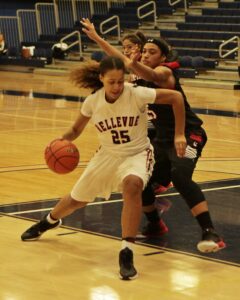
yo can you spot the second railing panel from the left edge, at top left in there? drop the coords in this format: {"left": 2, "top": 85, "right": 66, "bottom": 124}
{"left": 17, "top": 9, "right": 38, "bottom": 43}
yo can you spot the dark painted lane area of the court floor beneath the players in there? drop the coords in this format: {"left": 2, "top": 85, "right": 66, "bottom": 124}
{"left": 0, "top": 179, "right": 240, "bottom": 264}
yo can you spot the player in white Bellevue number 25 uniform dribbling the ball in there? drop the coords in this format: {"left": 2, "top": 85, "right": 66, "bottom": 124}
{"left": 21, "top": 57, "right": 186, "bottom": 280}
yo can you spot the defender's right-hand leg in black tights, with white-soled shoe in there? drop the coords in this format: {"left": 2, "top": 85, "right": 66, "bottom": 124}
{"left": 169, "top": 130, "right": 225, "bottom": 252}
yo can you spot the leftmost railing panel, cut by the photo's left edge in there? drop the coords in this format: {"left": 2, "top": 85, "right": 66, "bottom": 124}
{"left": 0, "top": 16, "right": 20, "bottom": 48}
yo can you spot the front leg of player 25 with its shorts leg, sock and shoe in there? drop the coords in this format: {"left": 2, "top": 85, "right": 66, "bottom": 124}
{"left": 118, "top": 149, "right": 154, "bottom": 280}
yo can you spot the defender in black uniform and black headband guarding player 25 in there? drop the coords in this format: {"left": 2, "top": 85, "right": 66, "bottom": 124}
{"left": 130, "top": 39, "right": 225, "bottom": 252}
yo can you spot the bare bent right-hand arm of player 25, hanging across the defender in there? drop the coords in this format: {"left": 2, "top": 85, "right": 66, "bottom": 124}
{"left": 155, "top": 89, "right": 187, "bottom": 157}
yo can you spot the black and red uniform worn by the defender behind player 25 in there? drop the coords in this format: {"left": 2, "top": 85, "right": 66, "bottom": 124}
{"left": 136, "top": 62, "right": 207, "bottom": 208}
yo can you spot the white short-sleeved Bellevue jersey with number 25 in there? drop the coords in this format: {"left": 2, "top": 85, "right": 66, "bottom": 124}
{"left": 81, "top": 83, "right": 156, "bottom": 156}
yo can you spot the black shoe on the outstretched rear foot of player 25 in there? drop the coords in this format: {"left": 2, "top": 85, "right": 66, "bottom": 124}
{"left": 21, "top": 217, "right": 62, "bottom": 241}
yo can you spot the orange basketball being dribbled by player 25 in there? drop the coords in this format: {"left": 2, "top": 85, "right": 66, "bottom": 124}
{"left": 45, "top": 140, "right": 80, "bottom": 174}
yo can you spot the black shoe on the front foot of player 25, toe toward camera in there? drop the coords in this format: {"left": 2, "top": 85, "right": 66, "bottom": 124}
{"left": 119, "top": 247, "right": 138, "bottom": 280}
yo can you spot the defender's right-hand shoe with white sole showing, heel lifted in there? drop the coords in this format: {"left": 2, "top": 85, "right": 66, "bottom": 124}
{"left": 197, "top": 228, "right": 226, "bottom": 253}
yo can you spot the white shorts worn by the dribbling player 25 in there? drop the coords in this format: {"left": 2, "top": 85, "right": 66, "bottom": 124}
{"left": 71, "top": 145, "right": 154, "bottom": 202}
